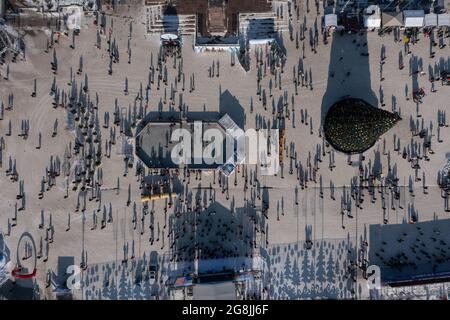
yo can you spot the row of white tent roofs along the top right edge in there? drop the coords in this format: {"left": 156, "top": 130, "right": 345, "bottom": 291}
{"left": 325, "top": 5, "right": 450, "bottom": 29}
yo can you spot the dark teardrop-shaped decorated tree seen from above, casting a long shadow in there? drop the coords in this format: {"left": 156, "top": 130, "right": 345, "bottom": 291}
{"left": 323, "top": 98, "right": 401, "bottom": 154}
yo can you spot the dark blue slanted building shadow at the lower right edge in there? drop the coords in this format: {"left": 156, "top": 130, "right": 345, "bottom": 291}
{"left": 369, "top": 219, "right": 450, "bottom": 286}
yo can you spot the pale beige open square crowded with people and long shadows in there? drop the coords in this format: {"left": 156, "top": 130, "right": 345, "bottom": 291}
{"left": 0, "top": 1, "right": 450, "bottom": 299}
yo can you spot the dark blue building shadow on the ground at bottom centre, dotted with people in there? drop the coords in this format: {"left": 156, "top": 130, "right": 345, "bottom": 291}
{"left": 169, "top": 202, "right": 257, "bottom": 278}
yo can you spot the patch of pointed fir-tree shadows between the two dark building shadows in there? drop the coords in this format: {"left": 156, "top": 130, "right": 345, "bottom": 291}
{"left": 263, "top": 239, "right": 356, "bottom": 300}
